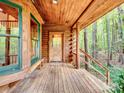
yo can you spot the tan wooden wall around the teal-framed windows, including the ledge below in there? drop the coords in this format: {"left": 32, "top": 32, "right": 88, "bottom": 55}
{"left": 0, "top": 0, "right": 43, "bottom": 88}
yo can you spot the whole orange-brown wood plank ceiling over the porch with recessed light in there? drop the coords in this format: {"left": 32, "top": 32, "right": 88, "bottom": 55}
{"left": 33, "top": 0, "right": 124, "bottom": 28}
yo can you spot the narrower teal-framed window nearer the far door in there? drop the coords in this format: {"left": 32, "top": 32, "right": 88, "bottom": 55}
{"left": 31, "top": 15, "right": 40, "bottom": 64}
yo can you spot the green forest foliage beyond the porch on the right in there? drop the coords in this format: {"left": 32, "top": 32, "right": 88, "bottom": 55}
{"left": 80, "top": 4, "right": 124, "bottom": 93}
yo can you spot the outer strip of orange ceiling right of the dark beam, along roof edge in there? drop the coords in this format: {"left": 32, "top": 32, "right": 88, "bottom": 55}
{"left": 80, "top": 0, "right": 124, "bottom": 29}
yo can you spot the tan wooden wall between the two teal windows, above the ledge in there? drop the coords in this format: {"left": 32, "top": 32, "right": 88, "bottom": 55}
{"left": 11, "top": 0, "right": 43, "bottom": 69}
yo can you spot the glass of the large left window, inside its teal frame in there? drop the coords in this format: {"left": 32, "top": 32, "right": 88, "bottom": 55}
{"left": 0, "top": 2, "right": 19, "bottom": 66}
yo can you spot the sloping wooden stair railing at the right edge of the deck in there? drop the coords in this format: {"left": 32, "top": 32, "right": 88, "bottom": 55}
{"left": 80, "top": 49, "right": 110, "bottom": 84}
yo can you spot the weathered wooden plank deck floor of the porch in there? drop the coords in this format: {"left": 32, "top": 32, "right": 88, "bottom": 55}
{"left": 11, "top": 63, "right": 108, "bottom": 93}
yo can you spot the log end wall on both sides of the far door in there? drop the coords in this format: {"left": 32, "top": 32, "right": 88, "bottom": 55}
{"left": 42, "top": 29, "right": 76, "bottom": 65}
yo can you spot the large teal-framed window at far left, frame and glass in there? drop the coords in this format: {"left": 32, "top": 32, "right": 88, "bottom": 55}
{"left": 0, "top": 1, "right": 21, "bottom": 72}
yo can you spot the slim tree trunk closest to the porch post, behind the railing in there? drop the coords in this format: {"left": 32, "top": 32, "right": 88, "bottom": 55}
{"left": 84, "top": 28, "right": 88, "bottom": 70}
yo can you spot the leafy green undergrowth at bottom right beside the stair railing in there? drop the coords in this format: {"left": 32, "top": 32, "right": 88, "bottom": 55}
{"left": 92, "top": 64, "right": 124, "bottom": 93}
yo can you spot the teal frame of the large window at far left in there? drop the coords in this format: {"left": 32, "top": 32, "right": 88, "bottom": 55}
{"left": 0, "top": 0, "right": 22, "bottom": 75}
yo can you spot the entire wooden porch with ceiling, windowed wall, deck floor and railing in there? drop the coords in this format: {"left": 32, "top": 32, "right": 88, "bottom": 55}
{"left": 0, "top": 0, "right": 124, "bottom": 93}
